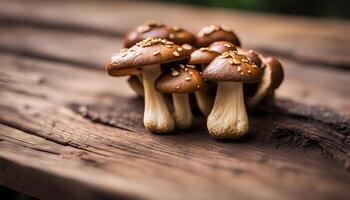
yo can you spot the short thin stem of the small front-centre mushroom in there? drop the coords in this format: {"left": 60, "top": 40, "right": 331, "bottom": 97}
{"left": 172, "top": 93, "right": 193, "bottom": 129}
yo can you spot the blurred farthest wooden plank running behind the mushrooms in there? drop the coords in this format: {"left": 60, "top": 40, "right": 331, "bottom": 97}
{"left": 0, "top": 1, "right": 350, "bottom": 69}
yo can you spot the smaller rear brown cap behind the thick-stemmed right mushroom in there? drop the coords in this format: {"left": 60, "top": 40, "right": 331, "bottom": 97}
{"left": 197, "top": 25, "right": 241, "bottom": 47}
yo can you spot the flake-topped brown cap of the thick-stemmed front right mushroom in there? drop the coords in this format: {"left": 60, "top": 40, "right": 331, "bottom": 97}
{"left": 203, "top": 51, "right": 263, "bottom": 83}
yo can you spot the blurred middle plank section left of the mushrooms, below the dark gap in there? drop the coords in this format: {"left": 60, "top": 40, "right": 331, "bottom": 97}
{"left": 0, "top": 25, "right": 122, "bottom": 69}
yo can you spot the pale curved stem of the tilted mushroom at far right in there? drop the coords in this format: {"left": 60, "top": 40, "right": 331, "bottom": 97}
{"left": 247, "top": 67, "right": 273, "bottom": 108}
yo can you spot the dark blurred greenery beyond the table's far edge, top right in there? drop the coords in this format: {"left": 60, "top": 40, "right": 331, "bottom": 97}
{"left": 163, "top": 0, "right": 350, "bottom": 18}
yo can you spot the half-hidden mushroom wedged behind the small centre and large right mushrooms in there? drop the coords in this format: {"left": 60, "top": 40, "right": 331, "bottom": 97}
{"left": 188, "top": 48, "right": 220, "bottom": 116}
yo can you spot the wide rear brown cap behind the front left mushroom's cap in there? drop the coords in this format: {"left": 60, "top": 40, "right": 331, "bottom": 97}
{"left": 124, "top": 22, "right": 196, "bottom": 48}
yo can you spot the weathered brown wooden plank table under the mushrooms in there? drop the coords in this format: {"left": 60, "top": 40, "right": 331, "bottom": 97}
{"left": 0, "top": 1, "right": 350, "bottom": 200}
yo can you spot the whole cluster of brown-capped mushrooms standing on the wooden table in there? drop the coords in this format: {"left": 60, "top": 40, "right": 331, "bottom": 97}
{"left": 106, "top": 22, "right": 284, "bottom": 139}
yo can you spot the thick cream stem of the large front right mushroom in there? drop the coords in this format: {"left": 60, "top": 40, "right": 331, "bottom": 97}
{"left": 207, "top": 82, "right": 249, "bottom": 138}
